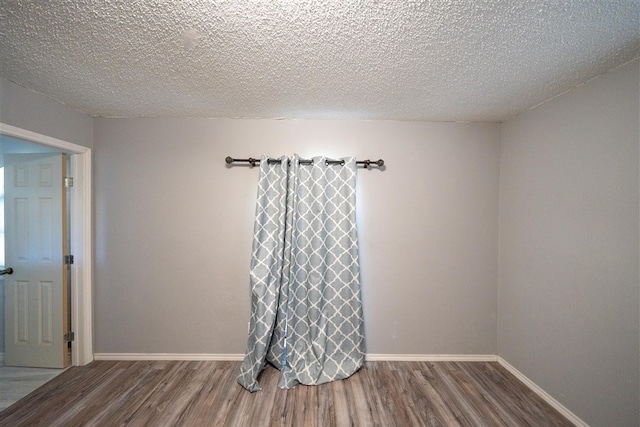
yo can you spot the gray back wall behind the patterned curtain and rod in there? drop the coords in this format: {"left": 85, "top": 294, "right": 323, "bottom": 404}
{"left": 94, "top": 119, "right": 499, "bottom": 355}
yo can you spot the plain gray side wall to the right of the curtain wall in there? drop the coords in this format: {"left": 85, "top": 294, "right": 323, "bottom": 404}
{"left": 498, "top": 60, "right": 640, "bottom": 426}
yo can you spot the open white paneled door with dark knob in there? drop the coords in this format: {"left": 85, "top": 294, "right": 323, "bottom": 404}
{"left": 3, "top": 153, "right": 68, "bottom": 368}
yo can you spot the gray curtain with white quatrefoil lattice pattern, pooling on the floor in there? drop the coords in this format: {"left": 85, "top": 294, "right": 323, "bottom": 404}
{"left": 238, "top": 155, "right": 364, "bottom": 392}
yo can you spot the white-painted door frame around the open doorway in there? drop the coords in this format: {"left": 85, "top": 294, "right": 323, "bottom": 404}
{"left": 0, "top": 122, "right": 94, "bottom": 366}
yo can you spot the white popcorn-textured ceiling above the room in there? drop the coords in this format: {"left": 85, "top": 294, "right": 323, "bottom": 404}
{"left": 0, "top": 0, "right": 640, "bottom": 121}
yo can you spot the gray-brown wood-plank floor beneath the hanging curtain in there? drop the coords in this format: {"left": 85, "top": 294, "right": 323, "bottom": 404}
{"left": 0, "top": 361, "right": 572, "bottom": 427}
